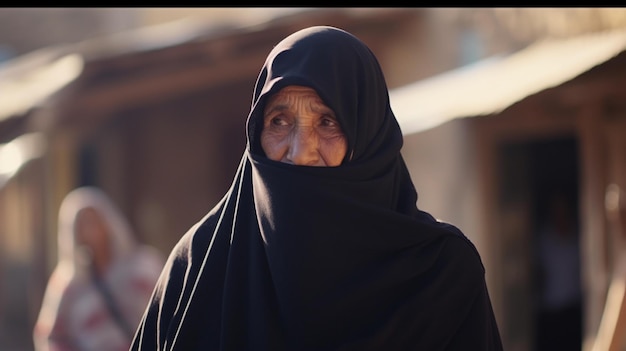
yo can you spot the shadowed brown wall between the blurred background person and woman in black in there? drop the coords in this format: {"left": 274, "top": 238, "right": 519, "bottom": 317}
{"left": 120, "top": 81, "right": 251, "bottom": 253}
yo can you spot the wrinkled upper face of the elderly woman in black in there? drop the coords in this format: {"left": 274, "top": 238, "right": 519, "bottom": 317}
{"left": 261, "top": 85, "right": 348, "bottom": 167}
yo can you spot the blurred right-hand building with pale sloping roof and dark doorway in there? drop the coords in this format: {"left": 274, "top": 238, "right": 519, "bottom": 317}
{"left": 392, "top": 24, "right": 626, "bottom": 350}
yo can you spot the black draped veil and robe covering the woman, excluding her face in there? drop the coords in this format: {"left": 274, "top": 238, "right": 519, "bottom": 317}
{"left": 131, "top": 27, "right": 502, "bottom": 351}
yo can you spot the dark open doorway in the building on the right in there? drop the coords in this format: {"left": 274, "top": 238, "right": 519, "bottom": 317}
{"left": 497, "top": 136, "right": 583, "bottom": 351}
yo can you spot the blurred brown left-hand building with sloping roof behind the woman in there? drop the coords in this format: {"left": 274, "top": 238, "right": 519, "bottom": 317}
{"left": 0, "top": 9, "right": 434, "bottom": 350}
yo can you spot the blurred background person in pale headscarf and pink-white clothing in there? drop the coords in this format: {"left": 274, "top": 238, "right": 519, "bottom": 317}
{"left": 33, "top": 187, "right": 165, "bottom": 351}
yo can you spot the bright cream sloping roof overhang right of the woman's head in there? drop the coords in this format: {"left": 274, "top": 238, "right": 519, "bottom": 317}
{"left": 390, "top": 30, "right": 626, "bottom": 135}
